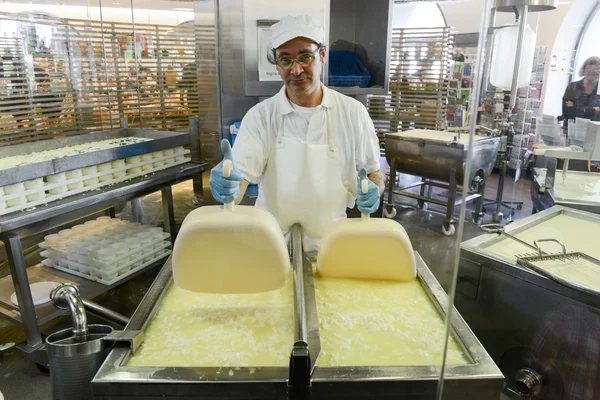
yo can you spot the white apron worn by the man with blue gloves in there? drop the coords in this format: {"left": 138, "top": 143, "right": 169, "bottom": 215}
{"left": 256, "top": 110, "right": 353, "bottom": 251}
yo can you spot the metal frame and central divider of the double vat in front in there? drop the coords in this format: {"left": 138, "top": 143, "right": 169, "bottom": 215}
{"left": 93, "top": 244, "right": 503, "bottom": 400}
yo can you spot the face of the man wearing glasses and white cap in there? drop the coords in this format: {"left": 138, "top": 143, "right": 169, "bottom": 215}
{"left": 275, "top": 38, "right": 326, "bottom": 96}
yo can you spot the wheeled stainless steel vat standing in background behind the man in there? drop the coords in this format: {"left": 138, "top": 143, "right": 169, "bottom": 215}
{"left": 385, "top": 130, "right": 500, "bottom": 236}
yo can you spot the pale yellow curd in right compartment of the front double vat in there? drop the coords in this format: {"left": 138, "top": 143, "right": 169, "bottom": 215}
{"left": 315, "top": 270, "right": 471, "bottom": 367}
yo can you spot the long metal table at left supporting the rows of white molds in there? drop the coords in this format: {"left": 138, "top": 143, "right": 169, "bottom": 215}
{"left": 0, "top": 163, "right": 207, "bottom": 363}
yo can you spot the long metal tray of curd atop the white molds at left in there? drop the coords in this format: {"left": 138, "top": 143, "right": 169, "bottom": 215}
{"left": 0, "top": 128, "right": 190, "bottom": 187}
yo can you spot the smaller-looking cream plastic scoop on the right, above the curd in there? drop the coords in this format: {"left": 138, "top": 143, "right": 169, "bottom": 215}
{"left": 317, "top": 218, "right": 417, "bottom": 281}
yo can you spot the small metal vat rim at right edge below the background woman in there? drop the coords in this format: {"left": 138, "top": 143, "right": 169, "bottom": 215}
{"left": 531, "top": 168, "right": 600, "bottom": 214}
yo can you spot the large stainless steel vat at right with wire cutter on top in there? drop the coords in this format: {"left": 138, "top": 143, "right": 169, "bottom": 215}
{"left": 455, "top": 206, "right": 600, "bottom": 398}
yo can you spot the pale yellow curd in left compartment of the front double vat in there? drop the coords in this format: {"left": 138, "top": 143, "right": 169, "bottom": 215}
{"left": 127, "top": 279, "right": 294, "bottom": 368}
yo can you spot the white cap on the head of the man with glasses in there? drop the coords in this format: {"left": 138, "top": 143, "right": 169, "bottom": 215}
{"left": 270, "top": 15, "right": 325, "bottom": 50}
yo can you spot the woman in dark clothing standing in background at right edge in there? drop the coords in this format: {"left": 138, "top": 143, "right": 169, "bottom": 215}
{"left": 563, "top": 56, "right": 600, "bottom": 129}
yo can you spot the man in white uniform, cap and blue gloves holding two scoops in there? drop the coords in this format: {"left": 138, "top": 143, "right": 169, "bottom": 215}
{"left": 210, "top": 16, "right": 385, "bottom": 248}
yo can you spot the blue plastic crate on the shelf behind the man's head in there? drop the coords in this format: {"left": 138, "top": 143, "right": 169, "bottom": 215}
{"left": 329, "top": 50, "right": 371, "bottom": 87}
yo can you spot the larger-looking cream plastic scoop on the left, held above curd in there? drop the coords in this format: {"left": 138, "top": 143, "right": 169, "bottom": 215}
{"left": 172, "top": 206, "right": 290, "bottom": 293}
